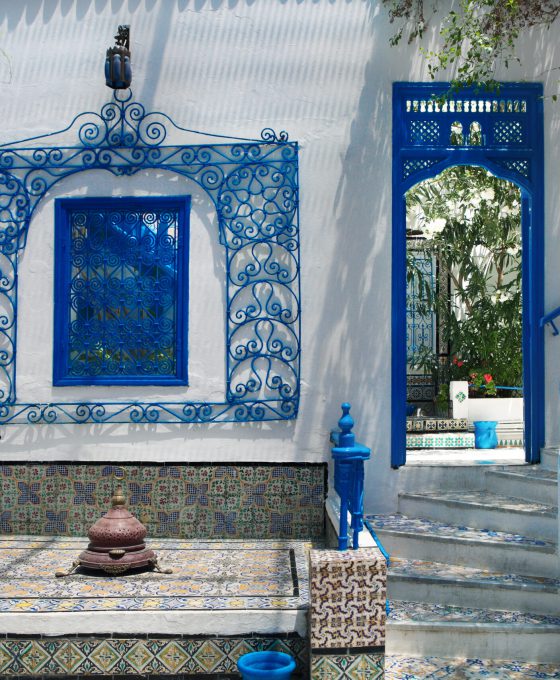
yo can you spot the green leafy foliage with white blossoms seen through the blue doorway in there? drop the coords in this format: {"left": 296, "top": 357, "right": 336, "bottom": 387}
{"left": 406, "top": 166, "right": 522, "bottom": 396}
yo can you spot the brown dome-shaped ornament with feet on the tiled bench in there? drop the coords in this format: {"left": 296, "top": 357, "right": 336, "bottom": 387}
{"left": 55, "top": 486, "right": 172, "bottom": 576}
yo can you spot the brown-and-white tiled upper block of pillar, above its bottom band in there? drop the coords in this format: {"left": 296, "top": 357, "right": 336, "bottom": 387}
{"left": 309, "top": 548, "right": 387, "bottom": 649}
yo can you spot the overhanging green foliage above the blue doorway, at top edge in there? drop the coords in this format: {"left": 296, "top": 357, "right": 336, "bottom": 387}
{"left": 382, "top": 0, "right": 560, "bottom": 94}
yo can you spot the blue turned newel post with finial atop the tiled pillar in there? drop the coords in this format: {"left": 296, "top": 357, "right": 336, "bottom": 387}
{"left": 331, "top": 402, "right": 371, "bottom": 550}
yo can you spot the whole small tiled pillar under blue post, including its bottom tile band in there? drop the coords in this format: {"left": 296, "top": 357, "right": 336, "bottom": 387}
{"left": 309, "top": 548, "right": 387, "bottom": 680}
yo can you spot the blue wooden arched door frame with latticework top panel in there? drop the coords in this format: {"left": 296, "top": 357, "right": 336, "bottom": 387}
{"left": 391, "top": 83, "right": 544, "bottom": 468}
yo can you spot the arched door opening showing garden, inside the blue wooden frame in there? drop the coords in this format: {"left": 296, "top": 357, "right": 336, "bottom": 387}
{"left": 406, "top": 165, "right": 525, "bottom": 464}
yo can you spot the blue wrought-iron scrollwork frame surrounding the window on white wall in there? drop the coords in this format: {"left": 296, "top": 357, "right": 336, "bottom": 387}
{"left": 0, "top": 90, "right": 300, "bottom": 423}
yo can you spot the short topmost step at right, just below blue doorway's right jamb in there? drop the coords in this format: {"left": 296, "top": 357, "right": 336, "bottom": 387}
{"left": 486, "top": 465, "right": 558, "bottom": 505}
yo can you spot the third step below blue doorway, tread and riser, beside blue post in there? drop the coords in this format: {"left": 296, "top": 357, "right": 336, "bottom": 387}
{"left": 367, "top": 514, "right": 558, "bottom": 578}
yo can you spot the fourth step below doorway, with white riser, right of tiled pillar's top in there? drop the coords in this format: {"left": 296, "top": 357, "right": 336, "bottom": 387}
{"left": 388, "top": 557, "right": 560, "bottom": 615}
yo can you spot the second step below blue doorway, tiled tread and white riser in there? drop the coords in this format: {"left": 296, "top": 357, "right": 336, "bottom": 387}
{"left": 399, "top": 491, "right": 558, "bottom": 542}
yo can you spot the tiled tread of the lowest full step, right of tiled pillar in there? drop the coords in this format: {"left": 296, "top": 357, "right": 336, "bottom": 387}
{"left": 389, "top": 600, "right": 560, "bottom": 634}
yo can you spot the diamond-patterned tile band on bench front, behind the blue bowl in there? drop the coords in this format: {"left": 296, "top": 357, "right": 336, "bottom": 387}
{"left": 0, "top": 636, "right": 308, "bottom": 679}
